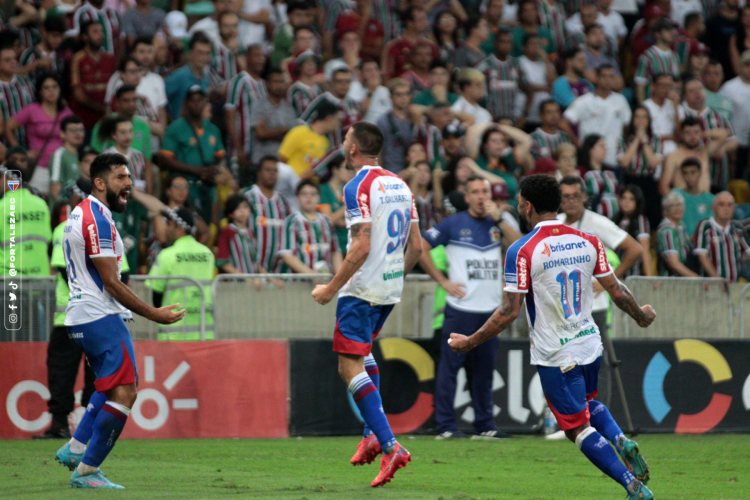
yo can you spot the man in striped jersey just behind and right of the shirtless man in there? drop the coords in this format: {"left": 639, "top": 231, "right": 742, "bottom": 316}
{"left": 678, "top": 78, "right": 737, "bottom": 190}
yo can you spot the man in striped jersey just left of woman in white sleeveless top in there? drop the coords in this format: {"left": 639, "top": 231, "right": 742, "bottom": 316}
{"left": 476, "top": 27, "right": 527, "bottom": 122}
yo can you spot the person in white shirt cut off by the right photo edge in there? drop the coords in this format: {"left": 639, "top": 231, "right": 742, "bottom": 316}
{"left": 720, "top": 49, "right": 750, "bottom": 178}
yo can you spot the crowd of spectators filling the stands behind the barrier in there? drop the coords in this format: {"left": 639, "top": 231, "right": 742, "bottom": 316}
{"left": 0, "top": 0, "right": 750, "bottom": 292}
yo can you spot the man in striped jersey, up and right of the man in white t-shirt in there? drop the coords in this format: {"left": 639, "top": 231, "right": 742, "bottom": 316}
{"left": 634, "top": 19, "right": 680, "bottom": 103}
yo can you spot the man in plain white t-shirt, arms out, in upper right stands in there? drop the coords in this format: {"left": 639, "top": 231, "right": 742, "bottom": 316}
{"left": 560, "top": 64, "right": 632, "bottom": 165}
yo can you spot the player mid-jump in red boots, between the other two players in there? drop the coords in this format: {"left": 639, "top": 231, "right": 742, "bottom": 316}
{"left": 312, "top": 122, "right": 422, "bottom": 487}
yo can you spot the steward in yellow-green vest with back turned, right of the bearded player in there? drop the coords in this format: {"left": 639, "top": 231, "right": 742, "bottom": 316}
{"left": 146, "top": 207, "right": 216, "bottom": 340}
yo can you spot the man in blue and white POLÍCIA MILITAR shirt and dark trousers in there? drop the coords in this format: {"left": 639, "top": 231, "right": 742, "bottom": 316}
{"left": 419, "top": 176, "right": 520, "bottom": 439}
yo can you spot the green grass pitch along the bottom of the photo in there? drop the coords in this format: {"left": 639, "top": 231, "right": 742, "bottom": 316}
{"left": 0, "top": 434, "right": 750, "bottom": 500}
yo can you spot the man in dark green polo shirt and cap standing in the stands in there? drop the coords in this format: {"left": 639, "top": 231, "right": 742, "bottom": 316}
{"left": 159, "top": 85, "right": 226, "bottom": 225}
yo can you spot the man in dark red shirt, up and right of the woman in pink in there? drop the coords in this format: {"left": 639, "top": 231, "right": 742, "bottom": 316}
{"left": 70, "top": 21, "right": 117, "bottom": 135}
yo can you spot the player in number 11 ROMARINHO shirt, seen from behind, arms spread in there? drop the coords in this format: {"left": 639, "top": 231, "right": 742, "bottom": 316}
{"left": 448, "top": 175, "right": 656, "bottom": 500}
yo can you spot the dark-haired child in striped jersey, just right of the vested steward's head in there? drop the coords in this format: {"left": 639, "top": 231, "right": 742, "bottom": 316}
{"left": 216, "top": 194, "right": 260, "bottom": 274}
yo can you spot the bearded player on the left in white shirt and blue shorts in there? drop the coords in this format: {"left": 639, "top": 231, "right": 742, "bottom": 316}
{"left": 55, "top": 154, "right": 185, "bottom": 489}
